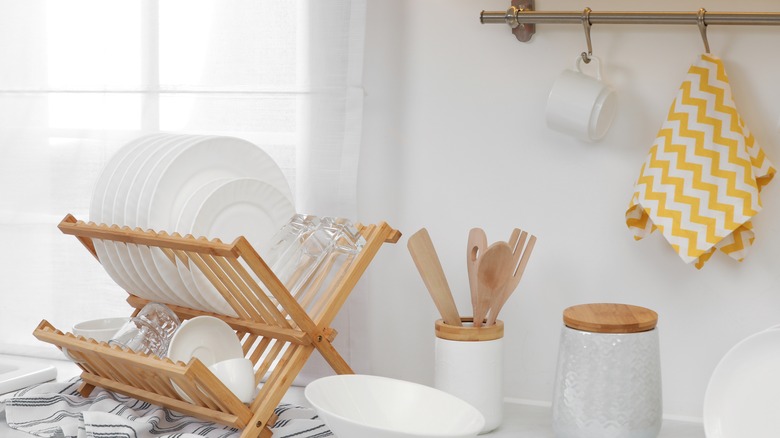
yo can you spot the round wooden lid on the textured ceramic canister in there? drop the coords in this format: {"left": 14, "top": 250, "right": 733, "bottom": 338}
{"left": 563, "top": 303, "right": 658, "bottom": 333}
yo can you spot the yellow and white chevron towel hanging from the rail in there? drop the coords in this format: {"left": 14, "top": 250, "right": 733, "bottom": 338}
{"left": 626, "top": 54, "right": 775, "bottom": 269}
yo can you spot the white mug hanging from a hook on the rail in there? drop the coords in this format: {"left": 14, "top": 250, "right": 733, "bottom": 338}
{"left": 547, "top": 56, "right": 617, "bottom": 142}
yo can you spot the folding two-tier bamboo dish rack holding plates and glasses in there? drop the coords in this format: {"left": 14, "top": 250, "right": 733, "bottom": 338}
{"left": 33, "top": 215, "right": 401, "bottom": 438}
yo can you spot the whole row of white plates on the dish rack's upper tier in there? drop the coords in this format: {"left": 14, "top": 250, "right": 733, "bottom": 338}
{"left": 89, "top": 134, "right": 295, "bottom": 316}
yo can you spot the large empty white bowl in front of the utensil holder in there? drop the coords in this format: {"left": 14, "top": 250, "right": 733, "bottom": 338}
{"left": 304, "top": 374, "right": 485, "bottom": 438}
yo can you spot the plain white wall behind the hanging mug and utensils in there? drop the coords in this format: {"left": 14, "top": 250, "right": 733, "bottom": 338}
{"left": 359, "top": 0, "right": 780, "bottom": 417}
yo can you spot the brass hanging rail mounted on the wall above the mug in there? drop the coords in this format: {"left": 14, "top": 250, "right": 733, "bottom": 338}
{"left": 479, "top": 0, "right": 780, "bottom": 41}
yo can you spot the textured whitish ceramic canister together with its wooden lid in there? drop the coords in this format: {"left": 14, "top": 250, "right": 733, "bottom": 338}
{"left": 553, "top": 304, "right": 662, "bottom": 438}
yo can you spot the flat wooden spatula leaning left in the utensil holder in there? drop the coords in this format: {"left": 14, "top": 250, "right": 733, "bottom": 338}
{"left": 406, "top": 228, "right": 463, "bottom": 326}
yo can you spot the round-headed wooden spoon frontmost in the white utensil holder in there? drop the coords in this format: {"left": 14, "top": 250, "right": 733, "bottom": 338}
{"left": 474, "top": 242, "right": 514, "bottom": 327}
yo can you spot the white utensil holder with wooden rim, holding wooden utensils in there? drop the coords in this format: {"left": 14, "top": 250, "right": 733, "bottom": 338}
{"left": 434, "top": 318, "right": 504, "bottom": 434}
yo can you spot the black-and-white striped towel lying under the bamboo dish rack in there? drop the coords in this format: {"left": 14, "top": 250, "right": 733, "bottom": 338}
{"left": 5, "top": 378, "right": 334, "bottom": 438}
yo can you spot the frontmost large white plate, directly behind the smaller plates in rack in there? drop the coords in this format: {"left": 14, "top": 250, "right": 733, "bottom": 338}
{"left": 137, "top": 137, "right": 292, "bottom": 316}
